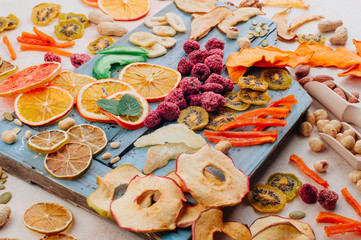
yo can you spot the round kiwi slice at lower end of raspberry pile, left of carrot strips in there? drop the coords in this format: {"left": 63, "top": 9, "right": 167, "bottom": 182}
{"left": 177, "top": 106, "right": 209, "bottom": 130}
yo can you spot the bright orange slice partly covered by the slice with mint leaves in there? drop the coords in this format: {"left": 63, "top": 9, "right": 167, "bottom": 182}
{"left": 76, "top": 78, "right": 135, "bottom": 123}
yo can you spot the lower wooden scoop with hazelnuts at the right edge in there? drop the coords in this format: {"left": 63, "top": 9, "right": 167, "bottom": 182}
{"left": 319, "top": 122, "right": 361, "bottom": 170}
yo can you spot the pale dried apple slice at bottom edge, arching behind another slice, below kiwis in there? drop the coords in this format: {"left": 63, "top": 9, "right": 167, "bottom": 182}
{"left": 250, "top": 215, "right": 315, "bottom": 240}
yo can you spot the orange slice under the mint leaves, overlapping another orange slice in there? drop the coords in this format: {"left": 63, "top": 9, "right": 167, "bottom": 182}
{"left": 104, "top": 91, "right": 149, "bottom": 130}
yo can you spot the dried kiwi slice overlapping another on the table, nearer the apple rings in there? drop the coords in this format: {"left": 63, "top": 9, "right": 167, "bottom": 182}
{"left": 247, "top": 183, "right": 287, "bottom": 213}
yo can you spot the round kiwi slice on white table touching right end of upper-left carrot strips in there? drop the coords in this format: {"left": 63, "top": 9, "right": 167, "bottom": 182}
{"left": 54, "top": 19, "right": 84, "bottom": 41}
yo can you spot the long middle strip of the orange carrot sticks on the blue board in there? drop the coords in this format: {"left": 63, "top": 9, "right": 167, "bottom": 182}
{"left": 218, "top": 118, "right": 287, "bottom": 131}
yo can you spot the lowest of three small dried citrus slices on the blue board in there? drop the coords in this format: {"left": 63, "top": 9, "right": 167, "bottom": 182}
{"left": 44, "top": 143, "right": 93, "bottom": 180}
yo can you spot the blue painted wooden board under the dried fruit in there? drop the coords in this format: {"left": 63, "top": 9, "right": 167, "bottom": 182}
{"left": 0, "top": 3, "right": 312, "bottom": 240}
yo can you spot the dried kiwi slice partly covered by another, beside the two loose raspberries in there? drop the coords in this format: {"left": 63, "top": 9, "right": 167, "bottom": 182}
{"left": 266, "top": 173, "right": 302, "bottom": 201}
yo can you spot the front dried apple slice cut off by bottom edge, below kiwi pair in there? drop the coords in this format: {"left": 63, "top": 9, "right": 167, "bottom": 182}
{"left": 252, "top": 222, "right": 309, "bottom": 240}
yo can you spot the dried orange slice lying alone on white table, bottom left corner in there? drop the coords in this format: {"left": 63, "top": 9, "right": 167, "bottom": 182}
{"left": 24, "top": 202, "right": 73, "bottom": 234}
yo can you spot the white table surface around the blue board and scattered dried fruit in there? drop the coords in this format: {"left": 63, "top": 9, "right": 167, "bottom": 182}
{"left": 0, "top": 0, "right": 361, "bottom": 240}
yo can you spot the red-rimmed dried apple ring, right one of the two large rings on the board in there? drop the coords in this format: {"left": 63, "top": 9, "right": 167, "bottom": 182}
{"left": 176, "top": 144, "right": 249, "bottom": 207}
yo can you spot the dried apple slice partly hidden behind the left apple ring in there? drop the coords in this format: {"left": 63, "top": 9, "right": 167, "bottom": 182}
{"left": 87, "top": 164, "right": 146, "bottom": 218}
